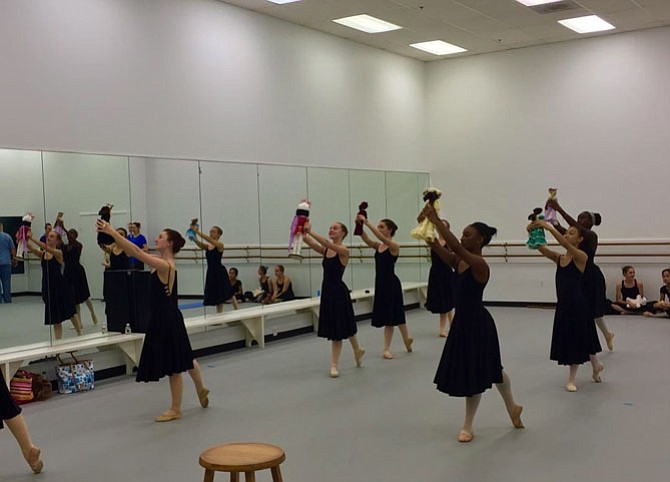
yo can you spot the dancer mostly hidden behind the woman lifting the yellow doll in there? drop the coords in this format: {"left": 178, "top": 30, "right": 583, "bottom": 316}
{"left": 426, "top": 219, "right": 454, "bottom": 338}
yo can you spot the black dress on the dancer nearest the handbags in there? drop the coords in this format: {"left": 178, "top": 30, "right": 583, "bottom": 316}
{"left": 135, "top": 267, "right": 193, "bottom": 382}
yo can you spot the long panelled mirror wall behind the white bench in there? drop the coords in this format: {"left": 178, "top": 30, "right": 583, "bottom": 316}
{"left": 0, "top": 145, "right": 429, "bottom": 350}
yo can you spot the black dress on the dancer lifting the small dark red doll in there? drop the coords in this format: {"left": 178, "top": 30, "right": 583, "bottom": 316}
{"left": 372, "top": 249, "right": 405, "bottom": 328}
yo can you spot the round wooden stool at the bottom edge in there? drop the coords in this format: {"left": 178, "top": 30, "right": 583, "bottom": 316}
{"left": 198, "top": 442, "right": 286, "bottom": 482}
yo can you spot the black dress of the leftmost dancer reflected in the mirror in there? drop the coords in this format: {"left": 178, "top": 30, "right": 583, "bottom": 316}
{"left": 41, "top": 253, "right": 77, "bottom": 325}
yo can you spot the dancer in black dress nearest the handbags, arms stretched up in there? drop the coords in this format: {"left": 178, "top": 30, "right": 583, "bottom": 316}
{"left": 96, "top": 219, "right": 209, "bottom": 422}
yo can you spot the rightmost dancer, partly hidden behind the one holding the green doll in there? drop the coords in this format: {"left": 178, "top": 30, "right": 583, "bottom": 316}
{"left": 547, "top": 199, "right": 614, "bottom": 351}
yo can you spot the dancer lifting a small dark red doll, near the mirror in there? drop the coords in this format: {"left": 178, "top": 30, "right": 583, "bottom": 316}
{"left": 356, "top": 214, "right": 414, "bottom": 360}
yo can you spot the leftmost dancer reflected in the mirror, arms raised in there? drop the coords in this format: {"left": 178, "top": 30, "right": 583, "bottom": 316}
{"left": 28, "top": 229, "right": 82, "bottom": 340}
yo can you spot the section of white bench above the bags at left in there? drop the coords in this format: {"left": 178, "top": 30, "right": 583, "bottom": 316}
{"left": 0, "top": 333, "right": 144, "bottom": 384}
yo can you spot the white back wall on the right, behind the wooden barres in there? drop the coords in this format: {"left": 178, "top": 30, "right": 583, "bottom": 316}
{"left": 426, "top": 28, "right": 670, "bottom": 301}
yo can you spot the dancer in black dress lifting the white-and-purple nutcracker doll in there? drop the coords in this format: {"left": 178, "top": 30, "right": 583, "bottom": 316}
{"left": 303, "top": 221, "right": 365, "bottom": 378}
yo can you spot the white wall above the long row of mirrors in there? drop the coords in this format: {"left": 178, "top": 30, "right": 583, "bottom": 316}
{"left": 0, "top": 0, "right": 424, "bottom": 170}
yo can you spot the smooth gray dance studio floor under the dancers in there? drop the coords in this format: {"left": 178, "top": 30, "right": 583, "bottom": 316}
{"left": 0, "top": 308, "right": 670, "bottom": 482}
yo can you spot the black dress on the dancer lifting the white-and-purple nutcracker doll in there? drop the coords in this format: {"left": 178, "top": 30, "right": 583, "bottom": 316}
{"left": 317, "top": 250, "right": 358, "bottom": 341}
